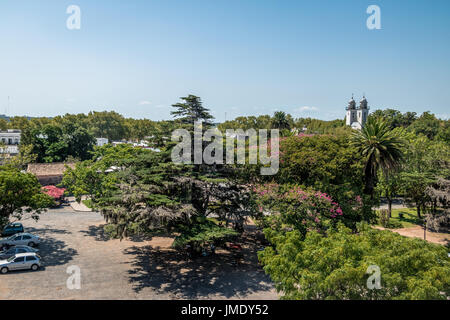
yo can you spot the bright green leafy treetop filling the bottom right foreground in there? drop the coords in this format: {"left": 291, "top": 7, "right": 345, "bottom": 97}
{"left": 259, "top": 222, "right": 450, "bottom": 300}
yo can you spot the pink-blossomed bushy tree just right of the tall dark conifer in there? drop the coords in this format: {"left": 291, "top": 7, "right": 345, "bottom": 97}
{"left": 253, "top": 183, "right": 343, "bottom": 238}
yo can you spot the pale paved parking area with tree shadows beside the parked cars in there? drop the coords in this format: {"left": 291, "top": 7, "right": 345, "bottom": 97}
{"left": 0, "top": 207, "right": 277, "bottom": 299}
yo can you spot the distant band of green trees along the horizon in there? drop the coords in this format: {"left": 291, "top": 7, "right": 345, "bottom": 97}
{"left": 0, "top": 109, "right": 450, "bottom": 142}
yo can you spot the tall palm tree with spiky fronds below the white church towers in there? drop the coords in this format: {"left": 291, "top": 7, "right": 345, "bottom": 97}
{"left": 351, "top": 117, "right": 405, "bottom": 197}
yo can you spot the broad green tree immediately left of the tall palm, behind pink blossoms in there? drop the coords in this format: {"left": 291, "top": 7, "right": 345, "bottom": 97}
{"left": 278, "top": 133, "right": 374, "bottom": 224}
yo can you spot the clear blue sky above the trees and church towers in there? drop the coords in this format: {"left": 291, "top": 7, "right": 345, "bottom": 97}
{"left": 0, "top": 0, "right": 450, "bottom": 121}
